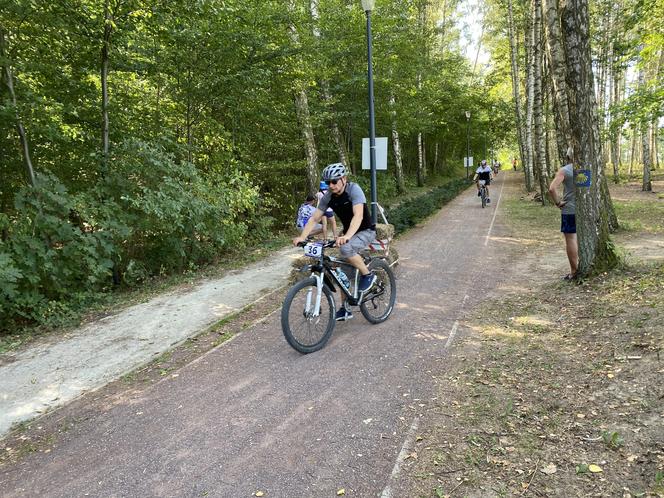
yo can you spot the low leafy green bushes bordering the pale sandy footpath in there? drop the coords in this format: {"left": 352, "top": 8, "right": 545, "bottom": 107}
{"left": 0, "top": 140, "right": 271, "bottom": 332}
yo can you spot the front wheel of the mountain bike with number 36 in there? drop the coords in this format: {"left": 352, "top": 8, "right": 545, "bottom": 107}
{"left": 281, "top": 277, "right": 336, "bottom": 354}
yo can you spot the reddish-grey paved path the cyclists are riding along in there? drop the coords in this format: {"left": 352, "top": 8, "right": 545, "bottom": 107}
{"left": 0, "top": 173, "right": 517, "bottom": 498}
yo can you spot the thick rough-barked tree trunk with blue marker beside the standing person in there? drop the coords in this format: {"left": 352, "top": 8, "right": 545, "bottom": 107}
{"left": 561, "top": 0, "right": 618, "bottom": 276}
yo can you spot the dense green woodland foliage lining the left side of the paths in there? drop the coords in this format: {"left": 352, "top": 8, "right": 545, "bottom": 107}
{"left": 0, "top": 0, "right": 492, "bottom": 330}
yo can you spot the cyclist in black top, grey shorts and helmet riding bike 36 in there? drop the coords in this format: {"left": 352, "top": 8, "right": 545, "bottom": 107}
{"left": 293, "top": 163, "right": 376, "bottom": 320}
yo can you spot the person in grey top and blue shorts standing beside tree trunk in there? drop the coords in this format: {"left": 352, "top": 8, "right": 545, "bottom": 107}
{"left": 549, "top": 147, "right": 579, "bottom": 280}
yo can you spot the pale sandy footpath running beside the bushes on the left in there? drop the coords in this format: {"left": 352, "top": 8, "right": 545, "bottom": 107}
{"left": 0, "top": 248, "right": 299, "bottom": 437}
